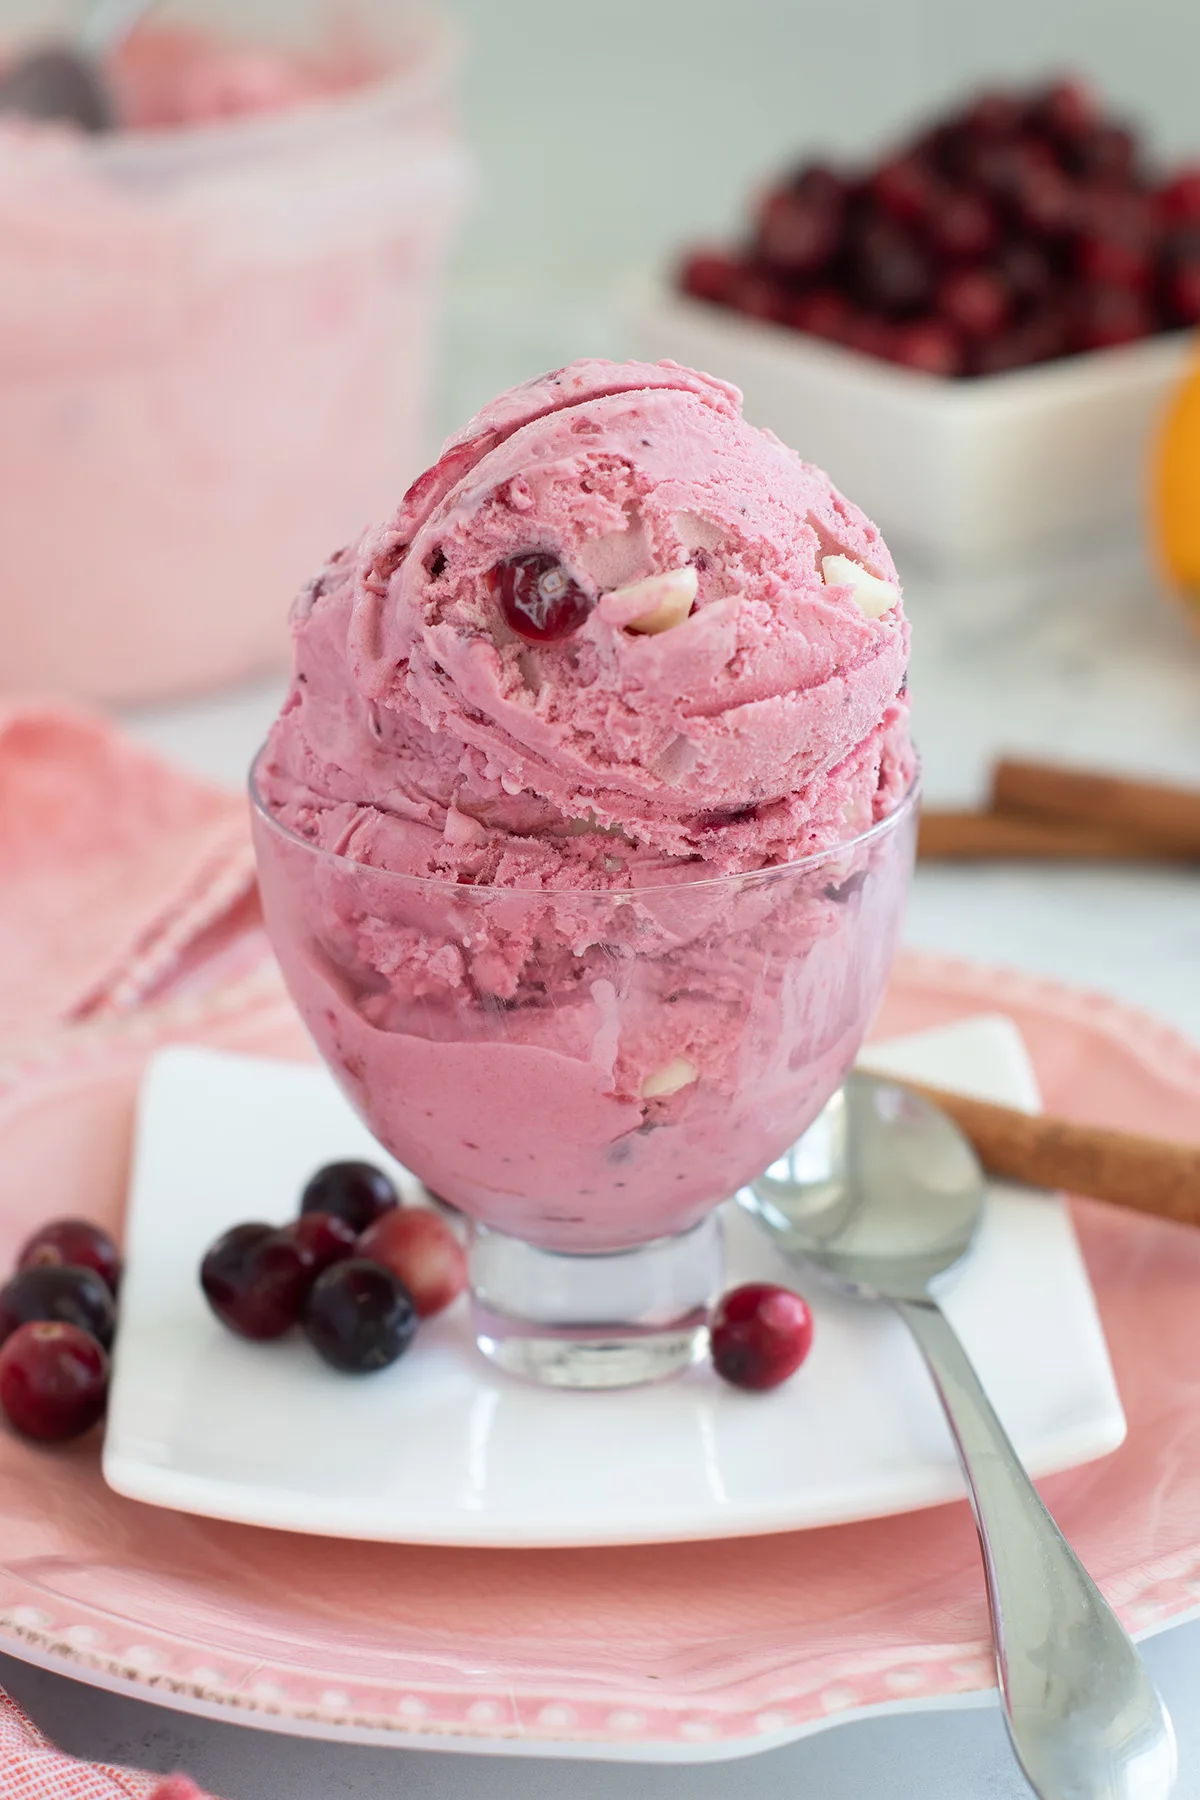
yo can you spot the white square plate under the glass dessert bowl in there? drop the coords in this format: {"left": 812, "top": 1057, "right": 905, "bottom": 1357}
{"left": 104, "top": 1017, "right": 1124, "bottom": 1546}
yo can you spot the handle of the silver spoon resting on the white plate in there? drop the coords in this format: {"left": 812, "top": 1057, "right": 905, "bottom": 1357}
{"left": 896, "top": 1300, "right": 1175, "bottom": 1800}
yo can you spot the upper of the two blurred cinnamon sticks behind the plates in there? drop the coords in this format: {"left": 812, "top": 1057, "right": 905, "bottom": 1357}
{"left": 991, "top": 758, "right": 1200, "bottom": 860}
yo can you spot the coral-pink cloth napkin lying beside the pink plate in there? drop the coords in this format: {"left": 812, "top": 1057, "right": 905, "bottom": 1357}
{"left": 0, "top": 706, "right": 244, "bottom": 1800}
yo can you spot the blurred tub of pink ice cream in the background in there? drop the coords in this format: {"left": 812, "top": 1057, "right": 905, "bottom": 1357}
{"left": 0, "top": 0, "right": 468, "bottom": 704}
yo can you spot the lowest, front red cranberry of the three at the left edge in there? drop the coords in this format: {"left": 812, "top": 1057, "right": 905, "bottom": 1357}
{"left": 0, "top": 1319, "right": 108, "bottom": 1444}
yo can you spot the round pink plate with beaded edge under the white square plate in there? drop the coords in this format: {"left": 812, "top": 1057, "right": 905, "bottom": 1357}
{"left": 0, "top": 956, "right": 1200, "bottom": 1760}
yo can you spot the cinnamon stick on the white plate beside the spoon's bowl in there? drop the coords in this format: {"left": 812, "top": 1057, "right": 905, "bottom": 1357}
{"left": 905, "top": 1082, "right": 1200, "bottom": 1226}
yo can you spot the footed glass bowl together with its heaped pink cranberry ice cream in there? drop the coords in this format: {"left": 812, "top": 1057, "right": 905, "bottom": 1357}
{"left": 254, "top": 362, "right": 916, "bottom": 1388}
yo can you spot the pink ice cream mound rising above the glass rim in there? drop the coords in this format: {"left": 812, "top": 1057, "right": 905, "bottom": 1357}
{"left": 263, "top": 362, "right": 912, "bottom": 887}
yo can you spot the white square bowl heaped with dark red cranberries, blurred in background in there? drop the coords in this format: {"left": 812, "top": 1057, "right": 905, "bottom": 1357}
{"left": 631, "top": 81, "right": 1200, "bottom": 563}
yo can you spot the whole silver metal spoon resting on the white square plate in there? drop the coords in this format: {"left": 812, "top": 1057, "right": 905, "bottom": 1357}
{"left": 738, "top": 1075, "right": 1177, "bottom": 1800}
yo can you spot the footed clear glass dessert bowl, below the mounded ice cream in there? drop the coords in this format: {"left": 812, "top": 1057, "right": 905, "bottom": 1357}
{"left": 252, "top": 774, "right": 918, "bottom": 1388}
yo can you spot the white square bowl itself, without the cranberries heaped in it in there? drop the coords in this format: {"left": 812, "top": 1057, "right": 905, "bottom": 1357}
{"left": 626, "top": 290, "right": 1193, "bottom": 567}
